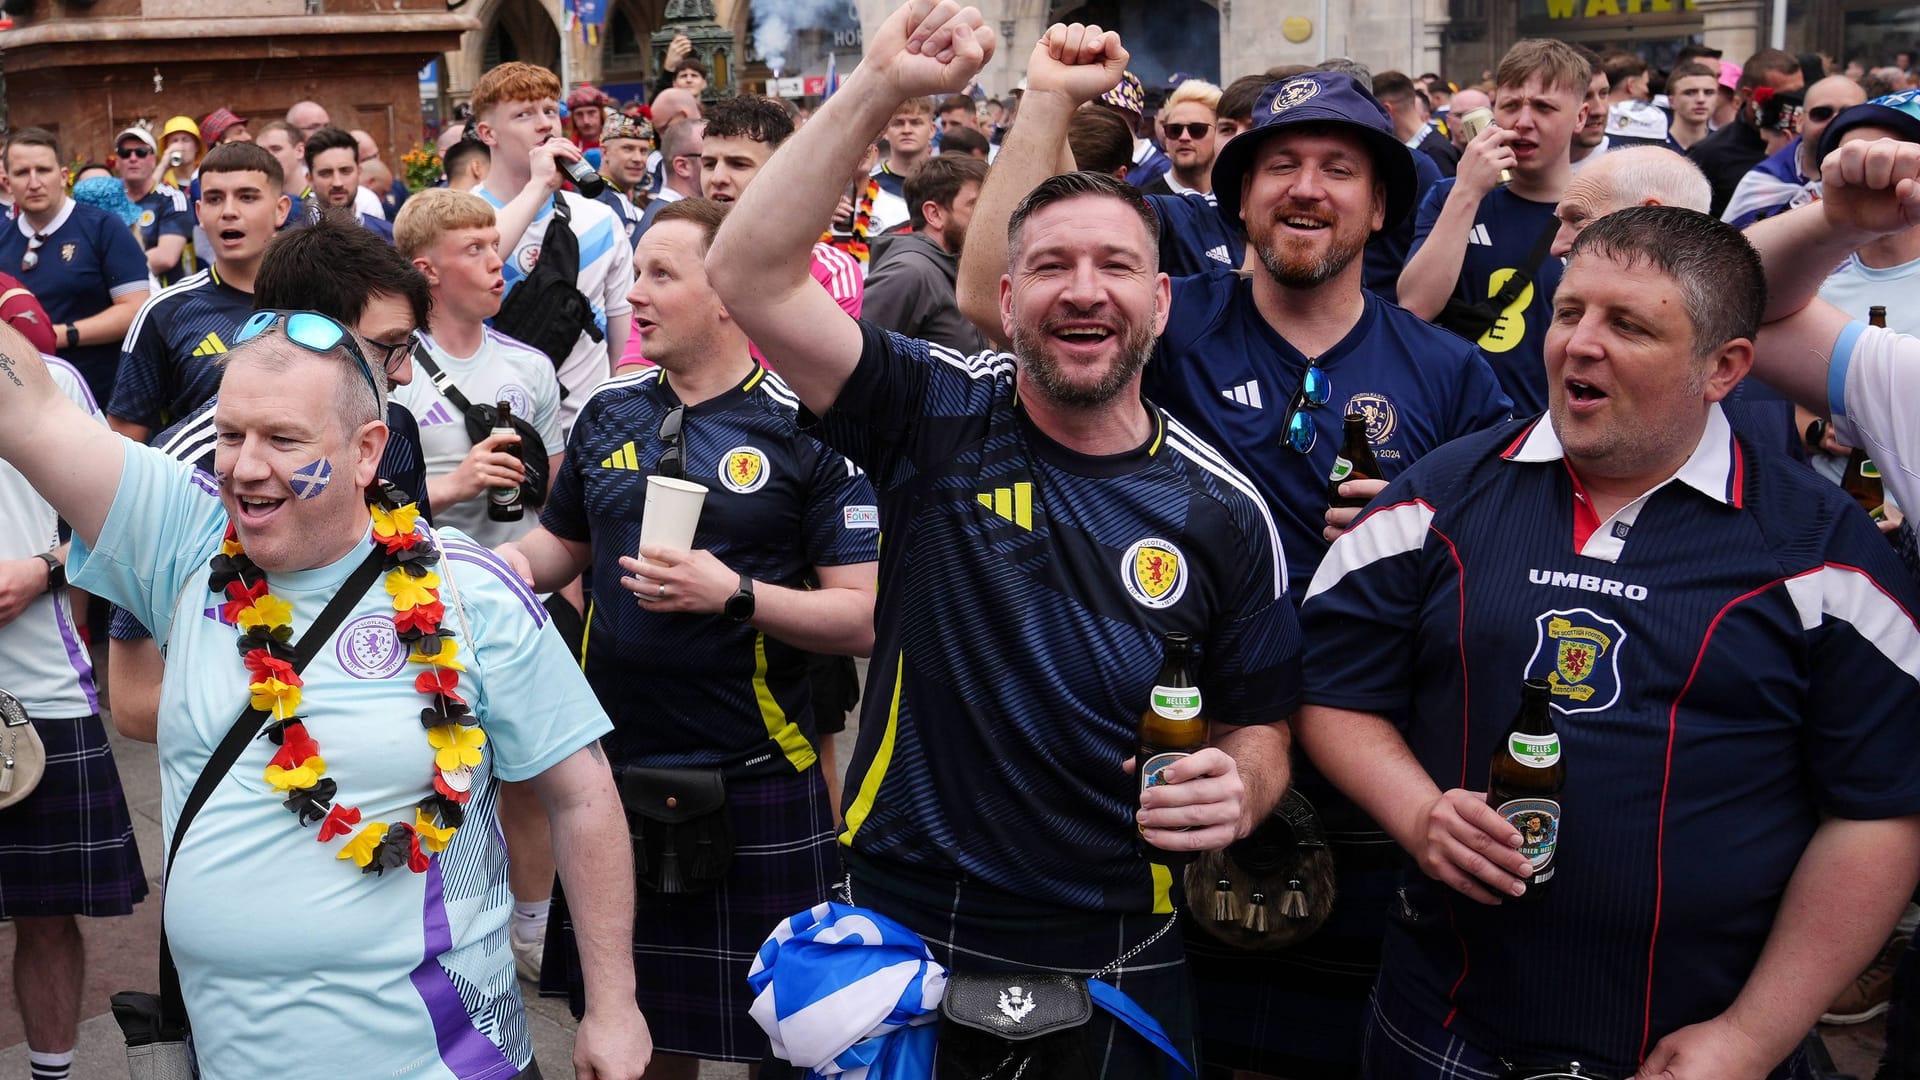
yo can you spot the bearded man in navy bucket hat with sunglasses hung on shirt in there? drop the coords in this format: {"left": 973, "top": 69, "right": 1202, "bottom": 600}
{"left": 960, "top": 56, "right": 1511, "bottom": 1074}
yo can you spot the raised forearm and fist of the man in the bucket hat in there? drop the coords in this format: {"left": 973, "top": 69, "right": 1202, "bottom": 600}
{"left": 956, "top": 23, "right": 1127, "bottom": 346}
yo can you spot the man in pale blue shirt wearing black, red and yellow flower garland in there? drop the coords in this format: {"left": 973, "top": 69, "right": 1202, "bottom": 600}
{"left": 0, "top": 311, "right": 651, "bottom": 1080}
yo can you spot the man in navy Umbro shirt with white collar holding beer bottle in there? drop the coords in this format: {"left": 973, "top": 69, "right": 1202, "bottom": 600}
{"left": 1296, "top": 206, "right": 1920, "bottom": 1080}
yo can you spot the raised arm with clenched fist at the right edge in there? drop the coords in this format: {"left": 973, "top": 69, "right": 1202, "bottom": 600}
{"left": 1747, "top": 138, "right": 1920, "bottom": 415}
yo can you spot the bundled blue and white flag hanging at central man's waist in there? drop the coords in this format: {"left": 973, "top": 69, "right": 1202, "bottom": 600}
{"left": 747, "top": 903, "right": 947, "bottom": 1080}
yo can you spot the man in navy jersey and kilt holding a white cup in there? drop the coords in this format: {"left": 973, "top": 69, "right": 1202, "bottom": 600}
{"left": 499, "top": 198, "right": 879, "bottom": 1080}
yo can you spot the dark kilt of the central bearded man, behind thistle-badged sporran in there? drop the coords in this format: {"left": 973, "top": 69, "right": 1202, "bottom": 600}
{"left": 843, "top": 855, "right": 1200, "bottom": 1080}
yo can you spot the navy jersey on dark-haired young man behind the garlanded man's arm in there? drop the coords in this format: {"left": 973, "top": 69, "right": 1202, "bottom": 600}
{"left": 108, "top": 267, "right": 253, "bottom": 432}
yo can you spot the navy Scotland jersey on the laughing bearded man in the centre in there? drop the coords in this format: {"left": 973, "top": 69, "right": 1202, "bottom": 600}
{"left": 816, "top": 323, "right": 1300, "bottom": 913}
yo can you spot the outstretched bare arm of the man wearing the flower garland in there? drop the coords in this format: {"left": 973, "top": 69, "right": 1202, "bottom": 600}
{"left": 0, "top": 317, "right": 125, "bottom": 546}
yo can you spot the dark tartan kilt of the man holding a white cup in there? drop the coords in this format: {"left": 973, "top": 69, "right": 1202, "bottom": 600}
{"left": 540, "top": 767, "right": 841, "bottom": 1063}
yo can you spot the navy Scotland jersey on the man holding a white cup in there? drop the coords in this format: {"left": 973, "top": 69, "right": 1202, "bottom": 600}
{"left": 540, "top": 367, "right": 879, "bottom": 776}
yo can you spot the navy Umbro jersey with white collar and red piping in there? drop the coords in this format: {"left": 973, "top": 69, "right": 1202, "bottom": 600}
{"left": 1302, "top": 405, "right": 1920, "bottom": 1076}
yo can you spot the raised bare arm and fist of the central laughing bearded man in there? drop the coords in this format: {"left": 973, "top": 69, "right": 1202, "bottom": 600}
{"left": 707, "top": 0, "right": 993, "bottom": 413}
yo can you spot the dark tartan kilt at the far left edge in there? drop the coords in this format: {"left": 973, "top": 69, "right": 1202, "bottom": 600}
{"left": 0, "top": 715, "right": 146, "bottom": 919}
